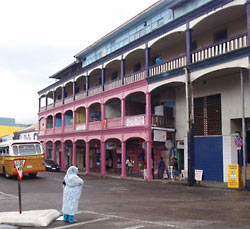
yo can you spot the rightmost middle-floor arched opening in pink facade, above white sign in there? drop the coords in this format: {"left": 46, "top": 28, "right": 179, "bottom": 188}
{"left": 126, "top": 92, "right": 146, "bottom": 116}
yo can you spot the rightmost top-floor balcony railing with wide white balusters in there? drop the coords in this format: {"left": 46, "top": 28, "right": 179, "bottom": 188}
{"left": 192, "top": 33, "right": 247, "bottom": 63}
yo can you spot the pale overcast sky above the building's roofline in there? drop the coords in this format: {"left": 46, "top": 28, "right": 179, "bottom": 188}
{"left": 0, "top": 0, "right": 157, "bottom": 124}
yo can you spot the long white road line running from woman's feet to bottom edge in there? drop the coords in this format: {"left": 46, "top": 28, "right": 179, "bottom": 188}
{"left": 77, "top": 211, "right": 188, "bottom": 229}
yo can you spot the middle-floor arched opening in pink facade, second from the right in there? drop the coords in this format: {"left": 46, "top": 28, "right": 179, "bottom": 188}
{"left": 105, "top": 98, "right": 121, "bottom": 119}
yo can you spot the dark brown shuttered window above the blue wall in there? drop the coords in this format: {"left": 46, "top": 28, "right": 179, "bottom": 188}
{"left": 194, "top": 94, "right": 222, "bottom": 136}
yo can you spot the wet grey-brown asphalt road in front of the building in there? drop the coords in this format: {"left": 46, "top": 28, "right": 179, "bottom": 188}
{"left": 0, "top": 172, "right": 250, "bottom": 229}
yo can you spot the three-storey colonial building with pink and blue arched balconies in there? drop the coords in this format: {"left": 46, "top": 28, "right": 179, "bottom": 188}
{"left": 38, "top": 0, "right": 250, "bottom": 182}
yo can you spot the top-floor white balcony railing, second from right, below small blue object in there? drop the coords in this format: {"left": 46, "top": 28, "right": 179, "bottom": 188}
{"left": 149, "top": 54, "right": 186, "bottom": 77}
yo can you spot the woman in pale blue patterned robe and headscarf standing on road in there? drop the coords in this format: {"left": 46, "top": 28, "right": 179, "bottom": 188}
{"left": 62, "top": 166, "right": 84, "bottom": 223}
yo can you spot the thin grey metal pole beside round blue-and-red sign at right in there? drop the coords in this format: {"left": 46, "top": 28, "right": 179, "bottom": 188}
{"left": 240, "top": 68, "right": 246, "bottom": 188}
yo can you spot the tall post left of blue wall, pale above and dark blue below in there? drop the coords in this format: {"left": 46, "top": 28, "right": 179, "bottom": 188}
{"left": 185, "top": 68, "right": 195, "bottom": 186}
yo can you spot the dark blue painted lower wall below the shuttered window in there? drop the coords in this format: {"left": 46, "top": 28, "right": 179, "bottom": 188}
{"left": 194, "top": 137, "right": 223, "bottom": 181}
